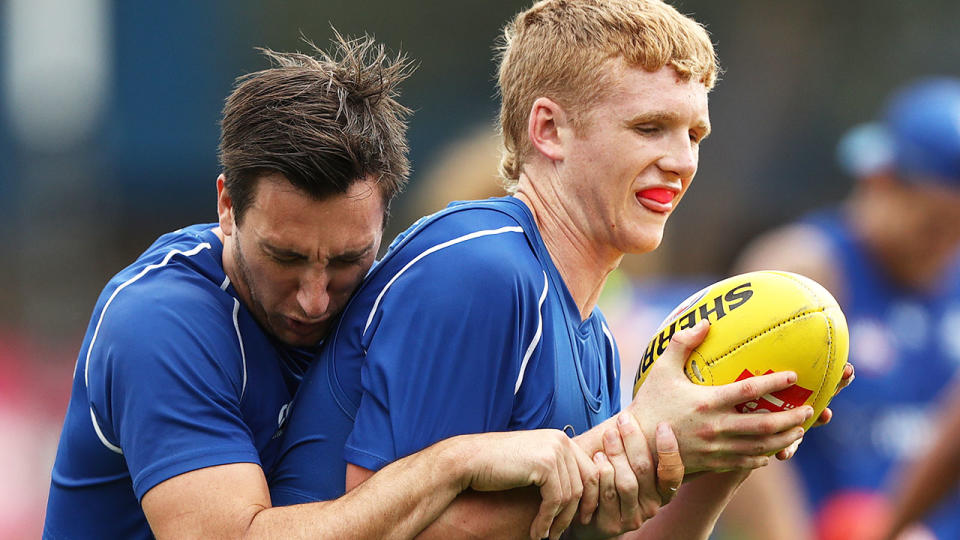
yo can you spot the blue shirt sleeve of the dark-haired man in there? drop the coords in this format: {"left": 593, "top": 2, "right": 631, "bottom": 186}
{"left": 86, "top": 285, "right": 259, "bottom": 498}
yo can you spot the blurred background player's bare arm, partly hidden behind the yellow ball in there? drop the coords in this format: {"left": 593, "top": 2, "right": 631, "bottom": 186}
{"left": 723, "top": 225, "right": 846, "bottom": 540}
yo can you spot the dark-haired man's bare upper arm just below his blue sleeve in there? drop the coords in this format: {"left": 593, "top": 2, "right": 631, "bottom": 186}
{"left": 141, "top": 463, "right": 270, "bottom": 539}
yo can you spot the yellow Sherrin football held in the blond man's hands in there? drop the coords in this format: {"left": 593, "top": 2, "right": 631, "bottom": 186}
{"left": 633, "top": 271, "right": 849, "bottom": 429}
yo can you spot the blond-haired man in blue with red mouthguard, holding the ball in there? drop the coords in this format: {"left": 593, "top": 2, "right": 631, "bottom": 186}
{"left": 271, "top": 0, "right": 840, "bottom": 538}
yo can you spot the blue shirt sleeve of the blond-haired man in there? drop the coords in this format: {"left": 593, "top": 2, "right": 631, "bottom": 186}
{"left": 344, "top": 242, "right": 543, "bottom": 470}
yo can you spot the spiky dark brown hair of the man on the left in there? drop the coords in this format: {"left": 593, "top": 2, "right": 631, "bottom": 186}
{"left": 220, "top": 30, "right": 413, "bottom": 224}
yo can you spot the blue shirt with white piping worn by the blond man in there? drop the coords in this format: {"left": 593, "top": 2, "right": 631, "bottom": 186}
{"left": 270, "top": 197, "right": 620, "bottom": 504}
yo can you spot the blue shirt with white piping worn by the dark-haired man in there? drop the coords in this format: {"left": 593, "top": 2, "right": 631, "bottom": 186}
{"left": 43, "top": 224, "right": 311, "bottom": 538}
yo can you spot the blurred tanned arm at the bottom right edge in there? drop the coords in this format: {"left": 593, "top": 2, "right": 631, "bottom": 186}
{"left": 882, "top": 377, "right": 960, "bottom": 540}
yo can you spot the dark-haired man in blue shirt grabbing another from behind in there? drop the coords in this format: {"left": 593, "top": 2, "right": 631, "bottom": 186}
{"left": 44, "top": 34, "right": 632, "bottom": 538}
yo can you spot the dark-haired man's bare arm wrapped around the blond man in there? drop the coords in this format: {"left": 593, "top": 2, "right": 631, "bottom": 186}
{"left": 142, "top": 430, "right": 597, "bottom": 540}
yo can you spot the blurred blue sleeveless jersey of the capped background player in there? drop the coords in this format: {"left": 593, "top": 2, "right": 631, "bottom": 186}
{"left": 794, "top": 212, "right": 960, "bottom": 539}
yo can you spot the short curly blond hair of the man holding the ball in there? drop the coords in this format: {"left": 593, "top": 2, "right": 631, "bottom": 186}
{"left": 498, "top": 0, "right": 719, "bottom": 187}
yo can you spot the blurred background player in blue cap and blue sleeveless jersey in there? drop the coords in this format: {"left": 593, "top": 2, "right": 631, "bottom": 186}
{"left": 728, "top": 78, "right": 960, "bottom": 540}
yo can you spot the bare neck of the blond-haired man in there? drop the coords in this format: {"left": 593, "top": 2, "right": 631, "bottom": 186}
{"left": 514, "top": 178, "right": 623, "bottom": 320}
